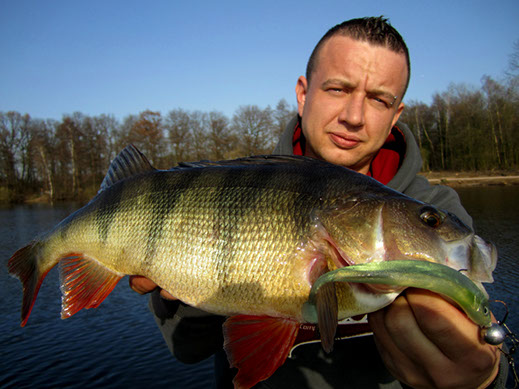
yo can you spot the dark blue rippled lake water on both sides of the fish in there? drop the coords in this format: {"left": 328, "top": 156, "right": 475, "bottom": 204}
{"left": 0, "top": 186, "right": 519, "bottom": 389}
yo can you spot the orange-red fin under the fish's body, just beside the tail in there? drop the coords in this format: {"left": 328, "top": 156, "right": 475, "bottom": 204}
{"left": 60, "top": 254, "right": 123, "bottom": 319}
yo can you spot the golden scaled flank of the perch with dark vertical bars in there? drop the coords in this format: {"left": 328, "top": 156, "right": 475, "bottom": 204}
{"left": 50, "top": 167, "right": 334, "bottom": 314}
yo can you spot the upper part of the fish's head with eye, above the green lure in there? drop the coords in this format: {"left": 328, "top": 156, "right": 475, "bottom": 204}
{"left": 320, "top": 194, "right": 497, "bottom": 282}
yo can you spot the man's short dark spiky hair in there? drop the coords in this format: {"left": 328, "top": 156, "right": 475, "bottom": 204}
{"left": 306, "top": 16, "right": 411, "bottom": 97}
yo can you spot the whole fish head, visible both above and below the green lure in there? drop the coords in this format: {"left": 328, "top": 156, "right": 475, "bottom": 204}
{"left": 308, "top": 192, "right": 497, "bottom": 319}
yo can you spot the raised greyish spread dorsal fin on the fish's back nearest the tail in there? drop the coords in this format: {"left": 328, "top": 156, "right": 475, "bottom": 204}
{"left": 100, "top": 145, "right": 156, "bottom": 190}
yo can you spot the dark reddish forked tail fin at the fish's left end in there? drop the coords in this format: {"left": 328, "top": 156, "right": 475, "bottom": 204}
{"left": 7, "top": 242, "right": 50, "bottom": 327}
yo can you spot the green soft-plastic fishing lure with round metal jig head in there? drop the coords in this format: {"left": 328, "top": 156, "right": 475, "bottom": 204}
{"left": 303, "top": 260, "right": 519, "bottom": 389}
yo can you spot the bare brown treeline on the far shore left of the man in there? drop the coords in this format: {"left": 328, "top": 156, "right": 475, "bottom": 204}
{"left": 0, "top": 100, "right": 296, "bottom": 203}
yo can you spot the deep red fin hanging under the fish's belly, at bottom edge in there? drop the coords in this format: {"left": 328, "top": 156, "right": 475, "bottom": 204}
{"left": 223, "top": 315, "right": 299, "bottom": 388}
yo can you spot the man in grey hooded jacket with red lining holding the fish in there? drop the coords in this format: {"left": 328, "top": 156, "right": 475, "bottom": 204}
{"left": 131, "top": 18, "right": 506, "bottom": 388}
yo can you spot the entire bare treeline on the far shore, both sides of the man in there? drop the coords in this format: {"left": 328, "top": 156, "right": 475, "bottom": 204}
{"left": 0, "top": 76, "right": 519, "bottom": 202}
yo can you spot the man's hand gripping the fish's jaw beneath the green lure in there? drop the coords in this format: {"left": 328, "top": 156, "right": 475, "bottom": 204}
{"left": 369, "top": 289, "right": 500, "bottom": 389}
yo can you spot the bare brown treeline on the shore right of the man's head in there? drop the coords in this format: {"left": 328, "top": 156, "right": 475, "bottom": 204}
{"left": 400, "top": 76, "right": 519, "bottom": 171}
